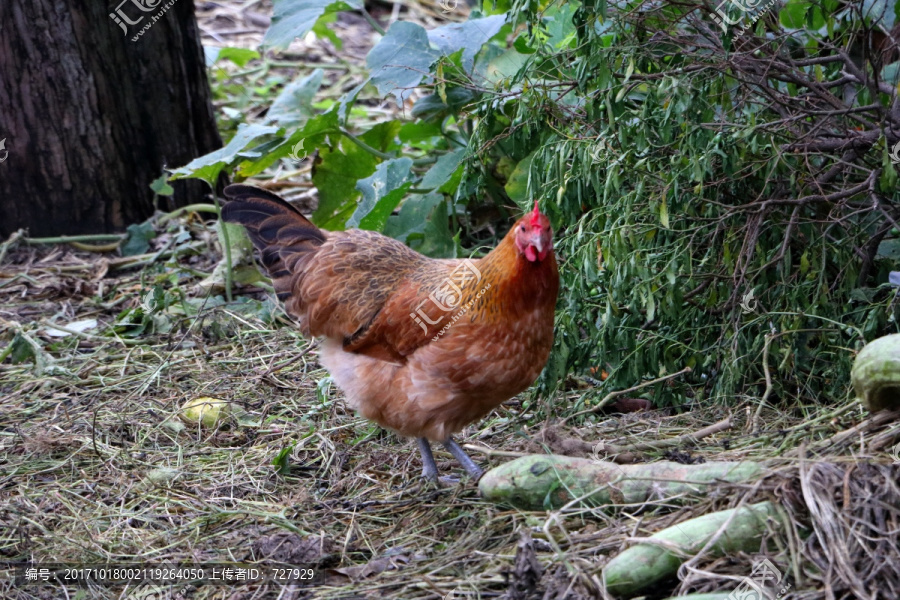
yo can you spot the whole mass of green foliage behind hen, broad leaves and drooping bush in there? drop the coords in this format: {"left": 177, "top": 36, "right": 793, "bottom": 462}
{"left": 175, "top": 0, "right": 900, "bottom": 412}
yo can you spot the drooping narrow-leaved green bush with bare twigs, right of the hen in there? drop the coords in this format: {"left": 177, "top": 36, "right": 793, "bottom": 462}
{"left": 496, "top": 1, "right": 900, "bottom": 404}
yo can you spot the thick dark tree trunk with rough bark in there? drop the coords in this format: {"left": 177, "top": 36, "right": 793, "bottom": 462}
{"left": 0, "top": 0, "right": 222, "bottom": 237}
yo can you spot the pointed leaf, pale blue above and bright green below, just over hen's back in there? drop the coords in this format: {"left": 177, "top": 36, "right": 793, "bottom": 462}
{"left": 347, "top": 157, "right": 412, "bottom": 231}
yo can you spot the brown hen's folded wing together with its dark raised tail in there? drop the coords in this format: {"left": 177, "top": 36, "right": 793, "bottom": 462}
{"left": 222, "top": 185, "right": 459, "bottom": 362}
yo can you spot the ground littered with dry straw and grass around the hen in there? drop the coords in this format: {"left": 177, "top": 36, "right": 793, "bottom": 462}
{"left": 0, "top": 1, "right": 900, "bottom": 600}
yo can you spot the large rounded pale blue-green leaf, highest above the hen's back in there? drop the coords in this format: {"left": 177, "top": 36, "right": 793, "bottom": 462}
{"left": 366, "top": 21, "right": 440, "bottom": 104}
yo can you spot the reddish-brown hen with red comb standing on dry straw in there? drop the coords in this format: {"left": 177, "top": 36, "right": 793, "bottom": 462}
{"left": 222, "top": 185, "right": 559, "bottom": 480}
